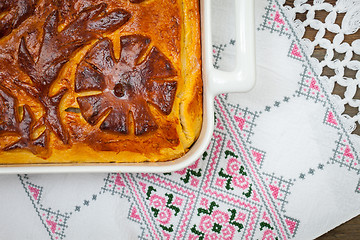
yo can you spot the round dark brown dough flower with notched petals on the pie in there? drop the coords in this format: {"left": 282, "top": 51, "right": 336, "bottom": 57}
{"left": 75, "top": 35, "right": 177, "bottom": 135}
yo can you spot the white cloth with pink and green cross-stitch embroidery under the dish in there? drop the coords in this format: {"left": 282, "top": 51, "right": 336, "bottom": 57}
{"left": 0, "top": 0, "right": 360, "bottom": 240}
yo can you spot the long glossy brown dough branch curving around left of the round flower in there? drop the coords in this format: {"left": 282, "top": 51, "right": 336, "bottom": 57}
{"left": 16, "top": 4, "right": 130, "bottom": 144}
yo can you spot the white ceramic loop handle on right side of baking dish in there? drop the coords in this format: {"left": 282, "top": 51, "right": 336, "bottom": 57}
{"left": 203, "top": 0, "right": 255, "bottom": 95}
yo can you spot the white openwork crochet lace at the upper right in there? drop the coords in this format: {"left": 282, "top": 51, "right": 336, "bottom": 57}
{"left": 280, "top": 0, "right": 360, "bottom": 138}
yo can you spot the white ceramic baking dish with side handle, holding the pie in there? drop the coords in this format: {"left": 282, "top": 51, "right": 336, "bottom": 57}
{"left": 0, "top": 0, "right": 255, "bottom": 174}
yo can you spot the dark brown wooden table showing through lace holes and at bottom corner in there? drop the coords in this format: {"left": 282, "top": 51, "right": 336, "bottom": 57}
{"left": 285, "top": 0, "right": 360, "bottom": 240}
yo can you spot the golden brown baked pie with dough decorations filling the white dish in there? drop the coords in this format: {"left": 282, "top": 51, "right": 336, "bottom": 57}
{"left": 0, "top": 0, "right": 202, "bottom": 164}
